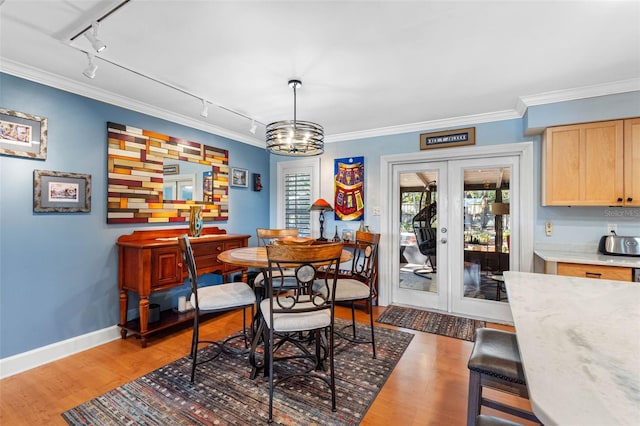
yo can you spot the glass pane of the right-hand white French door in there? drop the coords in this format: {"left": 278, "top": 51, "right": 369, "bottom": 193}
{"left": 463, "top": 167, "right": 511, "bottom": 302}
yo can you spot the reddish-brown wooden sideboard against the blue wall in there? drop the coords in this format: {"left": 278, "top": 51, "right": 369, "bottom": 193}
{"left": 116, "top": 227, "right": 250, "bottom": 348}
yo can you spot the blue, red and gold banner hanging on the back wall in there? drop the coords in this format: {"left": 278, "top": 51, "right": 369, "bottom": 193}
{"left": 334, "top": 157, "right": 364, "bottom": 220}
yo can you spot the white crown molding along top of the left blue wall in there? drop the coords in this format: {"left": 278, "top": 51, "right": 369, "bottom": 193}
{"left": 0, "top": 57, "right": 264, "bottom": 148}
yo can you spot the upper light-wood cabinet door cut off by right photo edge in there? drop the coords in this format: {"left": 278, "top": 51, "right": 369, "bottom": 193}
{"left": 624, "top": 118, "right": 640, "bottom": 206}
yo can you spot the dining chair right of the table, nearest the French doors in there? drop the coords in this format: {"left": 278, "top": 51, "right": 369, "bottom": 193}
{"left": 316, "top": 231, "right": 380, "bottom": 358}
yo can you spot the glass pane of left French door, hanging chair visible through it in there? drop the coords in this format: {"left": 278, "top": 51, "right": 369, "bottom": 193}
{"left": 400, "top": 171, "right": 438, "bottom": 293}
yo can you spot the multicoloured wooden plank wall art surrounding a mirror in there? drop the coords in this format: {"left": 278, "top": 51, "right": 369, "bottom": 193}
{"left": 107, "top": 122, "right": 229, "bottom": 223}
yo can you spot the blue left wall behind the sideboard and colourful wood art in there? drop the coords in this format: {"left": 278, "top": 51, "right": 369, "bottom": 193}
{"left": 0, "top": 74, "right": 269, "bottom": 358}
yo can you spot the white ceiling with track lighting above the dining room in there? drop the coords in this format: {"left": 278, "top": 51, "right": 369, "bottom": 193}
{"left": 0, "top": 0, "right": 640, "bottom": 146}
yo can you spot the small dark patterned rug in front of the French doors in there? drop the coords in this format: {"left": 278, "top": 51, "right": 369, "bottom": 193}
{"left": 376, "top": 305, "right": 486, "bottom": 342}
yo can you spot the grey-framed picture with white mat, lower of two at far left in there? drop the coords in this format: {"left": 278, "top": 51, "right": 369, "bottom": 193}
{"left": 33, "top": 170, "right": 91, "bottom": 213}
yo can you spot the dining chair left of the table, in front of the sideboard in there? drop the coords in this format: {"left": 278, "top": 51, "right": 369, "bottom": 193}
{"left": 178, "top": 234, "right": 256, "bottom": 383}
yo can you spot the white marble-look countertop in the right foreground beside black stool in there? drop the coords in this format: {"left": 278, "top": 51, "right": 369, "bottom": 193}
{"left": 504, "top": 271, "right": 640, "bottom": 426}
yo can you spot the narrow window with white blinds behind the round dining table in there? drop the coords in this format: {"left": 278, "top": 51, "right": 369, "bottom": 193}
{"left": 284, "top": 172, "right": 313, "bottom": 237}
